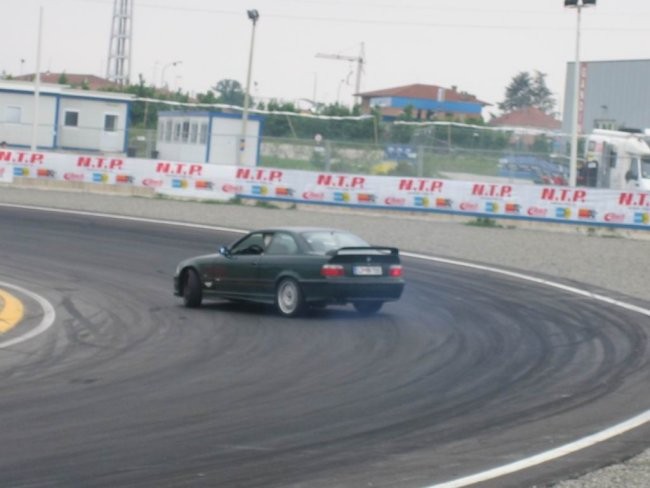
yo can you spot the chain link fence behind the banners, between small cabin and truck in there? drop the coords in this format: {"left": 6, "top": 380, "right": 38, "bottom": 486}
{"left": 123, "top": 123, "right": 570, "bottom": 184}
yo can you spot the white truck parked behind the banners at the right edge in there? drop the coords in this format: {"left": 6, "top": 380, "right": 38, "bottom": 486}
{"left": 577, "top": 129, "right": 650, "bottom": 191}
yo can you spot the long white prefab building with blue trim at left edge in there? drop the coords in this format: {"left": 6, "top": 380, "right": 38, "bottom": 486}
{"left": 0, "top": 80, "right": 134, "bottom": 153}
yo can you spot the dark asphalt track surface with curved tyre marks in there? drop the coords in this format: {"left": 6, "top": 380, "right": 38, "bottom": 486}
{"left": 0, "top": 208, "right": 650, "bottom": 488}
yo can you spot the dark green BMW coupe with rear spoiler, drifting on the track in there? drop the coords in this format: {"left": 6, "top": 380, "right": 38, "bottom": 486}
{"left": 174, "top": 227, "right": 404, "bottom": 317}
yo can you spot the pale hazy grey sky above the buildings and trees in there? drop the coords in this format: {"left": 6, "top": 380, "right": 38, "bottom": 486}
{"left": 0, "top": 0, "right": 650, "bottom": 117}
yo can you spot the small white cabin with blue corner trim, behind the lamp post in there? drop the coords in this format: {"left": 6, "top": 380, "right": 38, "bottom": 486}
{"left": 156, "top": 111, "right": 263, "bottom": 166}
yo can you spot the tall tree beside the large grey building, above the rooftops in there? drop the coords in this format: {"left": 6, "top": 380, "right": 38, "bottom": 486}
{"left": 498, "top": 71, "right": 555, "bottom": 113}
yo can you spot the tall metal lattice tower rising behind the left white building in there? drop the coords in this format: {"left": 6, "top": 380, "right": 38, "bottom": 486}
{"left": 106, "top": 0, "right": 133, "bottom": 85}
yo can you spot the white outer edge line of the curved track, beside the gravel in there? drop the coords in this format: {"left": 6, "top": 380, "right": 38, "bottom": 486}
{"left": 0, "top": 203, "right": 650, "bottom": 488}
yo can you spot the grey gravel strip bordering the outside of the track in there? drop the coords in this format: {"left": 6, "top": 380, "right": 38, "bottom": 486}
{"left": 0, "top": 185, "right": 650, "bottom": 488}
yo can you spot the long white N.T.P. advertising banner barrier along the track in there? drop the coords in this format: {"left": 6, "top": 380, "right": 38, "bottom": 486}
{"left": 0, "top": 150, "right": 650, "bottom": 230}
